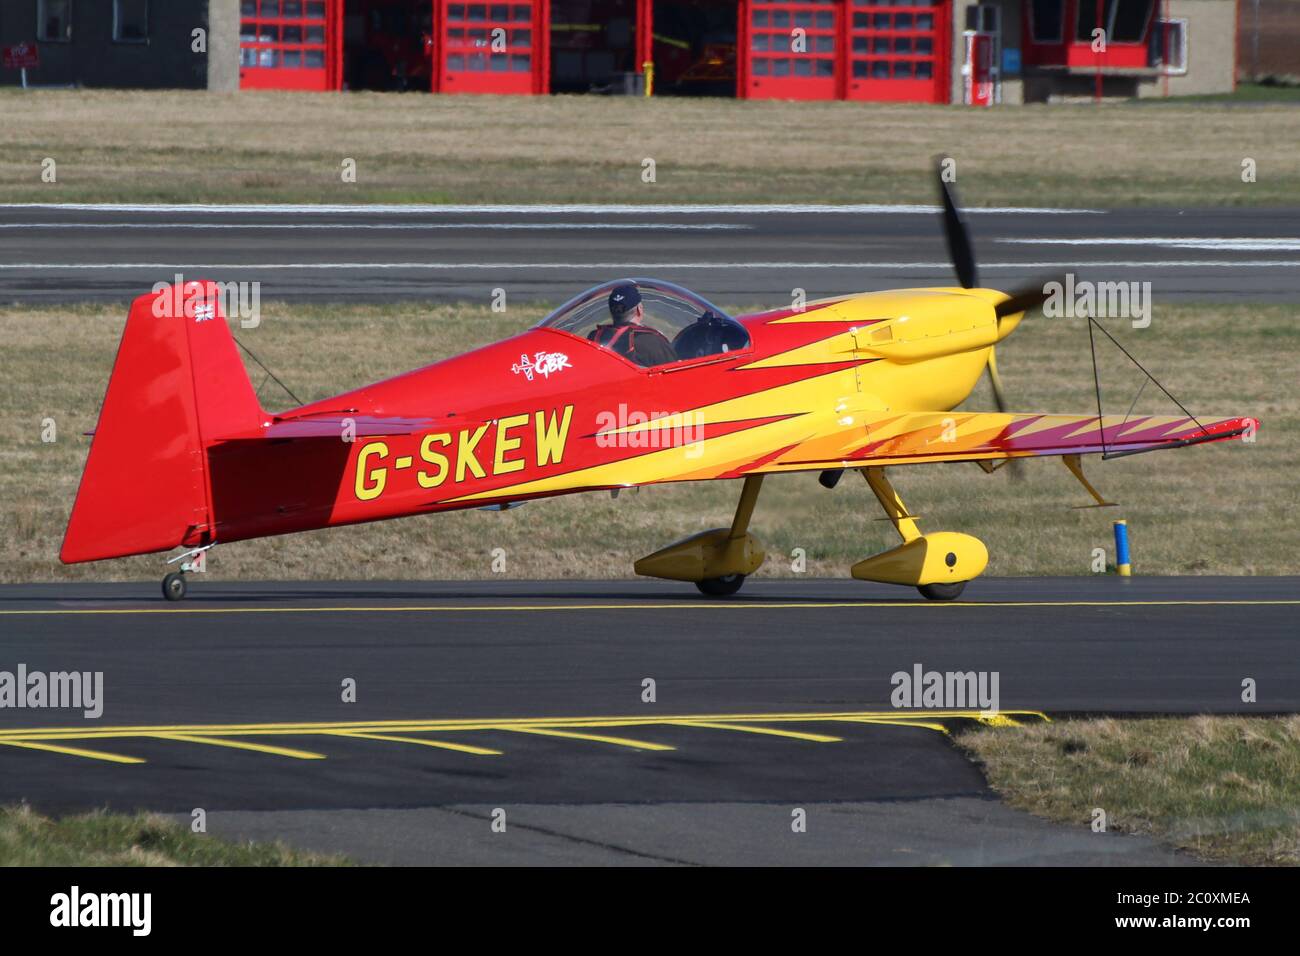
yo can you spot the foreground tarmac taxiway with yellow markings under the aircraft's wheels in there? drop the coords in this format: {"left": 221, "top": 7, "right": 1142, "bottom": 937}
{"left": 0, "top": 576, "right": 1300, "bottom": 864}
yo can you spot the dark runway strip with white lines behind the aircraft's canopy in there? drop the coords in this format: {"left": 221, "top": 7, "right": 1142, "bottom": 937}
{"left": 0, "top": 204, "right": 1300, "bottom": 307}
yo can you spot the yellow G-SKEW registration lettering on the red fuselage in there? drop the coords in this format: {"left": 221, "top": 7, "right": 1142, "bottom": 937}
{"left": 352, "top": 405, "right": 573, "bottom": 501}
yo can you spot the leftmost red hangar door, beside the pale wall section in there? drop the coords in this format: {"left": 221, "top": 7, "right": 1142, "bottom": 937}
{"left": 239, "top": 0, "right": 343, "bottom": 90}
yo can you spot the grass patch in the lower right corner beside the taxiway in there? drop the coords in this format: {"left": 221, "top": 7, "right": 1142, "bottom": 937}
{"left": 958, "top": 715, "right": 1300, "bottom": 865}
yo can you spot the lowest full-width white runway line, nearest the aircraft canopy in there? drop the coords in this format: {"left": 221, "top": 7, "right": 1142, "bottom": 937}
{"left": 0, "top": 259, "right": 1300, "bottom": 274}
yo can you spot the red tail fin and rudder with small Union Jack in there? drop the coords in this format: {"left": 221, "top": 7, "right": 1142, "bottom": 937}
{"left": 59, "top": 282, "right": 264, "bottom": 563}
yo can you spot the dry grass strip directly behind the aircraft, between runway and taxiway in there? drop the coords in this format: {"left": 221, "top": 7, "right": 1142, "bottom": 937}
{"left": 0, "top": 303, "right": 1300, "bottom": 581}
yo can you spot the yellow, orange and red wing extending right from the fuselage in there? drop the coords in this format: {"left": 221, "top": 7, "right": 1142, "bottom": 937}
{"left": 821, "top": 411, "right": 1258, "bottom": 467}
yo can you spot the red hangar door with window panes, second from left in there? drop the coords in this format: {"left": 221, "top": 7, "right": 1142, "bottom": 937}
{"left": 433, "top": 0, "right": 550, "bottom": 94}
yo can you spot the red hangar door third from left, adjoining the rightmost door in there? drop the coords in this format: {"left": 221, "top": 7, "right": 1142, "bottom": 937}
{"left": 736, "top": 0, "right": 842, "bottom": 100}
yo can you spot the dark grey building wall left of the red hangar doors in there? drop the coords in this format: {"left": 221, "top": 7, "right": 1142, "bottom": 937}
{"left": 0, "top": 0, "right": 208, "bottom": 88}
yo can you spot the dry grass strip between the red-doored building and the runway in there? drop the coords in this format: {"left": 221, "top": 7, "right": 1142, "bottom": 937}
{"left": 0, "top": 90, "right": 1300, "bottom": 206}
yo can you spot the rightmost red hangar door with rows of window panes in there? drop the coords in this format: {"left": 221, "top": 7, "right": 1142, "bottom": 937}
{"left": 845, "top": 0, "right": 952, "bottom": 103}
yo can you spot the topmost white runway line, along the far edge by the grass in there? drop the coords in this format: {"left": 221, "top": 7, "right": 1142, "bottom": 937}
{"left": 0, "top": 203, "right": 1104, "bottom": 216}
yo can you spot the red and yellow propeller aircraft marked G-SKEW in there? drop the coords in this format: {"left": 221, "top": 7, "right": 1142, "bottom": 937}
{"left": 60, "top": 178, "right": 1257, "bottom": 600}
